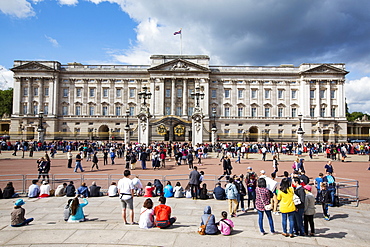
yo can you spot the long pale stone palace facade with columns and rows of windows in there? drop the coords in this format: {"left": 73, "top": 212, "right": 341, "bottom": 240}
{"left": 10, "top": 55, "right": 348, "bottom": 142}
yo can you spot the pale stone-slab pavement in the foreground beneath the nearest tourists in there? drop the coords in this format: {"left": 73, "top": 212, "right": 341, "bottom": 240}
{"left": 0, "top": 196, "right": 370, "bottom": 247}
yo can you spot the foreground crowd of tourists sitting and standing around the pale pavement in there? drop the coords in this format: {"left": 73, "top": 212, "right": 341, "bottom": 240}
{"left": 1, "top": 154, "right": 338, "bottom": 237}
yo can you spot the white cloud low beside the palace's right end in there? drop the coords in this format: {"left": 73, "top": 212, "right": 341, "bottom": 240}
{"left": 344, "top": 77, "right": 370, "bottom": 114}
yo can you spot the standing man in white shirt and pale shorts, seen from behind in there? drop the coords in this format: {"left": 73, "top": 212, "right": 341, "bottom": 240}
{"left": 117, "top": 170, "right": 137, "bottom": 225}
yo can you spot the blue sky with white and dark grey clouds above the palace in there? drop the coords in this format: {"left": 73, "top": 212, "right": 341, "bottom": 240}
{"left": 0, "top": 0, "right": 370, "bottom": 113}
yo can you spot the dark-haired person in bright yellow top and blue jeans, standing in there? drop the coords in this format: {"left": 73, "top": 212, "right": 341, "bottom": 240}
{"left": 277, "top": 178, "right": 296, "bottom": 238}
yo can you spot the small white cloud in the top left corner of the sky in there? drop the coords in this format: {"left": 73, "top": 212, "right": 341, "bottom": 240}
{"left": 0, "top": 0, "right": 37, "bottom": 18}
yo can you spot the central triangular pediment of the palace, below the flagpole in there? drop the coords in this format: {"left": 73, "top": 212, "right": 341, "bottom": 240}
{"left": 148, "top": 58, "right": 210, "bottom": 72}
